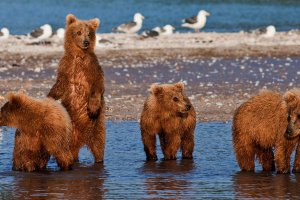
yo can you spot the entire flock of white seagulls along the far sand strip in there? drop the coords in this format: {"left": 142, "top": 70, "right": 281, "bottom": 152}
{"left": 0, "top": 10, "right": 276, "bottom": 43}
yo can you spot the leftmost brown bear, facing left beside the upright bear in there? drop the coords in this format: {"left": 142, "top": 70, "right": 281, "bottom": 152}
{"left": 0, "top": 93, "right": 74, "bottom": 172}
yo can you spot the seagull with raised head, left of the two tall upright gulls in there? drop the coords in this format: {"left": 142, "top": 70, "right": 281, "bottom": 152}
{"left": 113, "top": 13, "right": 144, "bottom": 33}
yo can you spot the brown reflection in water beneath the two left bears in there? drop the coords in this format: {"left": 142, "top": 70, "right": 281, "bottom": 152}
{"left": 7, "top": 164, "right": 106, "bottom": 199}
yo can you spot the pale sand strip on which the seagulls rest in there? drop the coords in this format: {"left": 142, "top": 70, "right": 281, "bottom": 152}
{"left": 0, "top": 32, "right": 300, "bottom": 57}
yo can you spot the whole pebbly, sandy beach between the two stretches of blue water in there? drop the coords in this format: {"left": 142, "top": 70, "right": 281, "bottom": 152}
{"left": 0, "top": 31, "right": 300, "bottom": 121}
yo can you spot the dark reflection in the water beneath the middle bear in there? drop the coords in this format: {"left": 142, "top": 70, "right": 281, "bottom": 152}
{"left": 142, "top": 160, "right": 194, "bottom": 199}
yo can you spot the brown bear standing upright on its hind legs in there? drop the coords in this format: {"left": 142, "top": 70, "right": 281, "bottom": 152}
{"left": 48, "top": 14, "right": 105, "bottom": 162}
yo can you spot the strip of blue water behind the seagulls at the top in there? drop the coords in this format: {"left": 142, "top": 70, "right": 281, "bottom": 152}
{"left": 0, "top": 0, "right": 300, "bottom": 34}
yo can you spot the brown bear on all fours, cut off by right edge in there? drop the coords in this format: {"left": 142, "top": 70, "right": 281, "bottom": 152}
{"left": 232, "top": 89, "right": 300, "bottom": 173}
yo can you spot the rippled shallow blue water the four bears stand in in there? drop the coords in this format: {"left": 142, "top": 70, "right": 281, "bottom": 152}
{"left": 0, "top": 122, "right": 300, "bottom": 199}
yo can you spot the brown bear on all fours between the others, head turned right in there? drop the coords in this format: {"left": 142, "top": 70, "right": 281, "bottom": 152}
{"left": 140, "top": 83, "right": 196, "bottom": 161}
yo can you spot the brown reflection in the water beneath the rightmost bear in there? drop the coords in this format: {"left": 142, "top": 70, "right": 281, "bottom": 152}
{"left": 233, "top": 172, "right": 300, "bottom": 199}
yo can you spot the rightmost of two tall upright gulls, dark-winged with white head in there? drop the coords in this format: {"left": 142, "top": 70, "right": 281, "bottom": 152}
{"left": 181, "top": 10, "right": 210, "bottom": 32}
